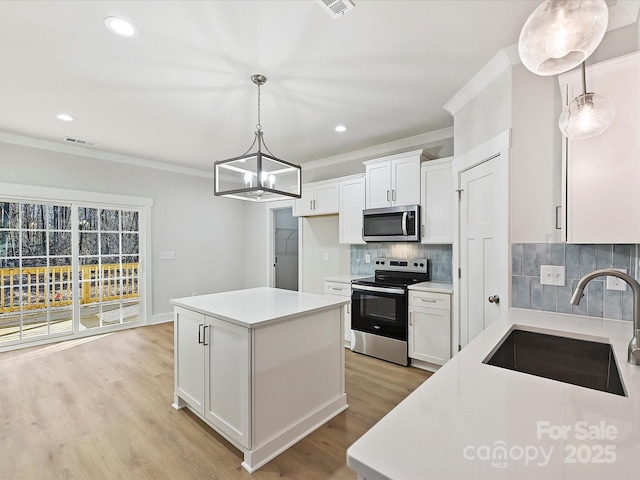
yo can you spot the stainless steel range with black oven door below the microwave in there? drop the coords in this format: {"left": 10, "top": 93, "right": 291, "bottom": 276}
{"left": 351, "top": 258, "right": 429, "bottom": 365}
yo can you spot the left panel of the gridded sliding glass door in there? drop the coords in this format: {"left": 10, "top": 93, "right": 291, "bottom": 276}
{"left": 0, "top": 202, "right": 73, "bottom": 343}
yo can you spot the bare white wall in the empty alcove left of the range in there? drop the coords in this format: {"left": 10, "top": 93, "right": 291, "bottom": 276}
{"left": 300, "top": 215, "right": 351, "bottom": 294}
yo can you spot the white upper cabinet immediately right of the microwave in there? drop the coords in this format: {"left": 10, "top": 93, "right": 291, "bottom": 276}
{"left": 420, "top": 157, "right": 455, "bottom": 243}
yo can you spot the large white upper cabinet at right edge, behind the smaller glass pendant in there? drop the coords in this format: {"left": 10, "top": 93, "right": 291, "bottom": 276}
{"left": 558, "top": 52, "right": 640, "bottom": 243}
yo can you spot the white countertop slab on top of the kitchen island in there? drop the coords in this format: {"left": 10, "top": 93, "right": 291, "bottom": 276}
{"left": 171, "top": 287, "right": 351, "bottom": 328}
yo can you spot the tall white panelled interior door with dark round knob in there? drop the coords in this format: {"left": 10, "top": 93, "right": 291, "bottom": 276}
{"left": 458, "top": 152, "right": 509, "bottom": 346}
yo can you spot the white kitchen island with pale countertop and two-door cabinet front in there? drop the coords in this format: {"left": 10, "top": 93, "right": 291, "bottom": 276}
{"left": 171, "top": 287, "right": 348, "bottom": 472}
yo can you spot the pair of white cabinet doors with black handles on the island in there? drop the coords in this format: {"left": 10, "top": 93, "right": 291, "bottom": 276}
{"left": 175, "top": 308, "right": 251, "bottom": 447}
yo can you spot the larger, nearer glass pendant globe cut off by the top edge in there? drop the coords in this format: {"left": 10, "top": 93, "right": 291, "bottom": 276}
{"left": 518, "top": 0, "right": 609, "bottom": 76}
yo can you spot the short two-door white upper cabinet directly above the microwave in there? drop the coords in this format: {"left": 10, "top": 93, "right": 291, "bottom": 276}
{"left": 364, "top": 150, "right": 423, "bottom": 208}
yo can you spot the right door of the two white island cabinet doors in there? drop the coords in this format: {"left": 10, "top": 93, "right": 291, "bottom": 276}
{"left": 205, "top": 316, "right": 251, "bottom": 448}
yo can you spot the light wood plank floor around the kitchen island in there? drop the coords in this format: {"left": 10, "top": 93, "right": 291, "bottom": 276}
{"left": 0, "top": 323, "right": 429, "bottom": 480}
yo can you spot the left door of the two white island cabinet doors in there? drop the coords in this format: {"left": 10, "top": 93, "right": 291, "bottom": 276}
{"left": 174, "top": 307, "right": 205, "bottom": 415}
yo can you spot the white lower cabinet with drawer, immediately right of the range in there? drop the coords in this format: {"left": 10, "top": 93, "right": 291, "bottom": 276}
{"left": 409, "top": 290, "right": 451, "bottom": 365}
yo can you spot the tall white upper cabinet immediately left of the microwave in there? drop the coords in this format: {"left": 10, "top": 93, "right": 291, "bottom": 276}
{"left": 338, "top": 175, "right": 365, "bottom": 244}
